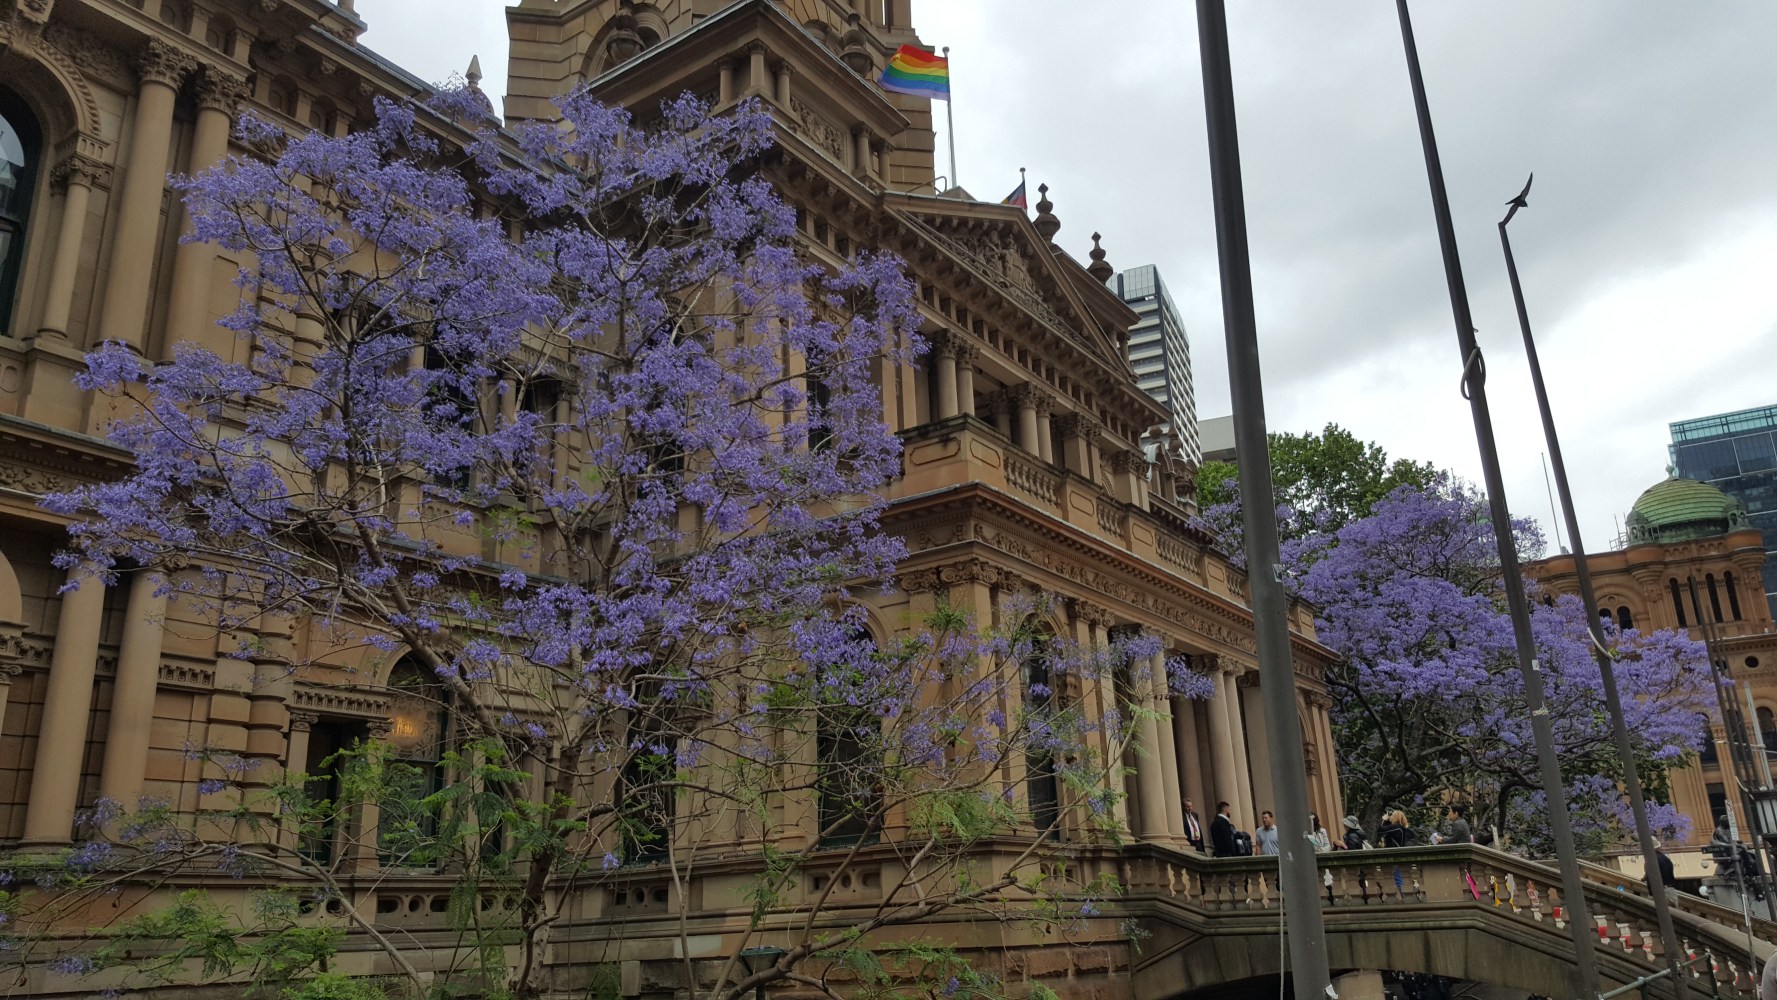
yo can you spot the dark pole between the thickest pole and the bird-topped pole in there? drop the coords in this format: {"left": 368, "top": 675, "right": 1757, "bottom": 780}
{"left": 1393, "top": 0, "right": 1598, "bottom": 998}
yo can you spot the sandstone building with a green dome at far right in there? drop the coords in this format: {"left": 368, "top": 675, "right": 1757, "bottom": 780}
{"left": 1525, "top": 476, "right": 1777, "bottom": 877}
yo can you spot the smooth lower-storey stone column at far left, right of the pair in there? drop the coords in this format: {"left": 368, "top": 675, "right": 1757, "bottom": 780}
{"left": 100, "top": 570, "right": 167, "bottom": 808}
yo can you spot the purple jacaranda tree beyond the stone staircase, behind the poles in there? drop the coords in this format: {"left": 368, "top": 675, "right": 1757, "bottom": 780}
{"left": 1205, "top": 476, "right": 1709, "bottom": 851}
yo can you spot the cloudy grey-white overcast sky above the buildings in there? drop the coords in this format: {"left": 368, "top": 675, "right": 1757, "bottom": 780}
{"left": 357, "top": 0, "right": 1777, "bottom": 551}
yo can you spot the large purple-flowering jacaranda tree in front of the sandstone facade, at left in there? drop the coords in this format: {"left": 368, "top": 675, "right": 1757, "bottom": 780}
{"left": 0, "top": 92, "right": 1201, "bottom": 998}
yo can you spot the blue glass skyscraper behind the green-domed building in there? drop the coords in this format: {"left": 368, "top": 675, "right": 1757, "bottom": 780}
{"left": 1672, "top": 405, "right": 1777, "bottom": 609}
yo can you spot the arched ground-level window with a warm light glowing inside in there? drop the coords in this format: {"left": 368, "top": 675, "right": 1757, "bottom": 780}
{"left": 377, "top": 657, "right": 450, "bottom": 869}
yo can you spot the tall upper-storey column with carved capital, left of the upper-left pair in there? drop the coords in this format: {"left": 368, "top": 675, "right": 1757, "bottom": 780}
{"left": 98, "top": 41, "right": 195, "bottom": 350}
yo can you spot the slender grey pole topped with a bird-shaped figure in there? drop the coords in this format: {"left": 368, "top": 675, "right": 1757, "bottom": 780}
{"left": 1500, "top": 174, "right": 1685, "bottom": 1000}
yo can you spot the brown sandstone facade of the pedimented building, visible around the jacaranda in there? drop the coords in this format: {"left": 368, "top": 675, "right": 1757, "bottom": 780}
{"left": 0, "top": 0, "right": 1336, "bottom": 995}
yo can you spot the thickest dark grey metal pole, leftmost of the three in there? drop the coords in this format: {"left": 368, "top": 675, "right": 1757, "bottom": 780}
{"left": 1198, "top": 0, "right": 1338, "bottom": 1000}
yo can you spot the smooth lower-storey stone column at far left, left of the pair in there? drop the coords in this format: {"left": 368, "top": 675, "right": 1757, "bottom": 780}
{"left": 20, "top": 567, "right": 105, "bottom": 845}
